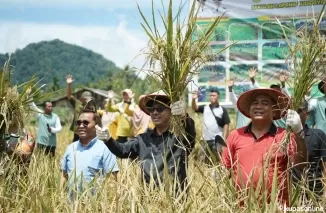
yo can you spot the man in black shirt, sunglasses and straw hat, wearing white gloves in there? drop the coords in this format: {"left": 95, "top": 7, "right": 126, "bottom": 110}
{"left": 97, "top": 91, "right": 196, "bottom": 192}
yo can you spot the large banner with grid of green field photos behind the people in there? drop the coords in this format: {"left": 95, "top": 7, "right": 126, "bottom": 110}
{"left": 189, "top": 0, "right": 326, "bottom": 106}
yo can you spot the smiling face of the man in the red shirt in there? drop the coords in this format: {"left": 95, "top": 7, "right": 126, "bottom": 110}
{"left": 249, "top": 94, "right": 276, "bottom": 121}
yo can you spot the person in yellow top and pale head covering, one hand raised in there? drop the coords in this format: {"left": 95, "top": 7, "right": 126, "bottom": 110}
{"left": 106, "top": 89, "right": 135, "bottom": 143}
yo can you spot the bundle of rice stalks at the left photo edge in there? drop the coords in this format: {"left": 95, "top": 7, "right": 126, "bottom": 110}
{"left": 0, "top": 58, "right": 47, "bottom": 139}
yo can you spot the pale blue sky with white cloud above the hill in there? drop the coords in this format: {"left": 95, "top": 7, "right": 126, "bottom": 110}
{"left": 0, "top": 0, "right": 184, "bottom": 70}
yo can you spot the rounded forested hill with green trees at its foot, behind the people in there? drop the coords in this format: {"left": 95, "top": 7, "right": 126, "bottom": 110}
{"left": 0, "top": 40, "right": 159, "bottom": 99}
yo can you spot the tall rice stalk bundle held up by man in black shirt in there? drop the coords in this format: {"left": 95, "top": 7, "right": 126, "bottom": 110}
{"left": 138, "top": 0, "right": 226, "bottom": 135}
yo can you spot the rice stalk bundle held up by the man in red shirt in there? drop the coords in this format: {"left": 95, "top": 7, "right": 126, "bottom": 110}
{"left": 278, "top": 5, "right": 326, "bottom": 151}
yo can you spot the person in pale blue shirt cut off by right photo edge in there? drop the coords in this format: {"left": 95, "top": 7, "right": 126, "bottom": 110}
{"left": 308, "top": 78, "right": 326, "bottom": 133}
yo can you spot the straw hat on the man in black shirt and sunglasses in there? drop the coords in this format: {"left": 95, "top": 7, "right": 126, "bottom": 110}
{"left": 139, "top": 90, "right": 171, "bottom": 115}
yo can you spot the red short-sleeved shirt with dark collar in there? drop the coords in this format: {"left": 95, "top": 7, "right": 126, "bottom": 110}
{"left": 222, "top": 123, "right": 296, "bottom": 204}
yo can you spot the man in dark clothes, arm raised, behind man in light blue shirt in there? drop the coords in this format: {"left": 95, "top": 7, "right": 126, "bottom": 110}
{"left": 66, "top": 75, "right": 96, "bottom": 142}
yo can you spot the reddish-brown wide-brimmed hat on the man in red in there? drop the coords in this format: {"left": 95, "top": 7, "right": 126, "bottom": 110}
{"left": 237, "top": 88, "right": 289, "bottom": 120}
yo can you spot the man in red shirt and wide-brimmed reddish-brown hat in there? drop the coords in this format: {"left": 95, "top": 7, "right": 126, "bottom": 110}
{"left": 222, "top": 89, "right": 307, "bottom": 204}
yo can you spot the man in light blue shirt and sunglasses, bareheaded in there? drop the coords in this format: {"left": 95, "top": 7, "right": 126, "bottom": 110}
{"left": 61, "top": 111, "right": 119, "bottom": 199}
